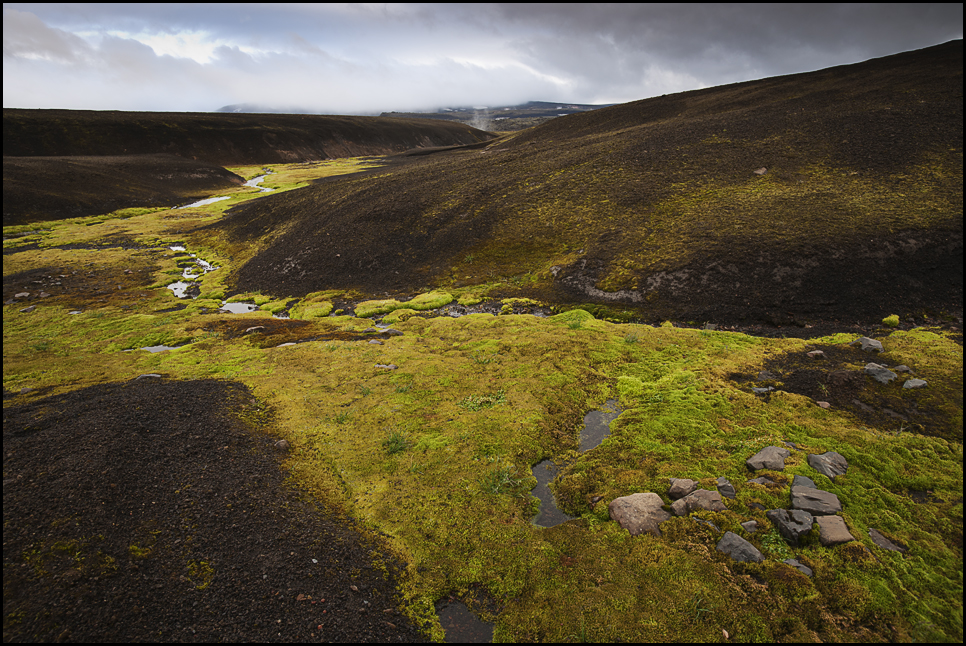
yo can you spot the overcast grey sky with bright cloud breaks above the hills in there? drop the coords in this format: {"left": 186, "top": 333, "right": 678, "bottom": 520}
{"left": 3, "top": 3, "right": 963, "bottom": 114}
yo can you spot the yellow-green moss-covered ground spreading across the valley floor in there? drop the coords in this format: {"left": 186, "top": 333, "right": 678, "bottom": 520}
{"left": 3, "top": 165, "right": 963, "bottom": 642}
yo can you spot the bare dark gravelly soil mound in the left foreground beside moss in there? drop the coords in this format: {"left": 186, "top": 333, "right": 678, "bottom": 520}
{"left": 3, "top": 377, "right": 422, "bottom": 642}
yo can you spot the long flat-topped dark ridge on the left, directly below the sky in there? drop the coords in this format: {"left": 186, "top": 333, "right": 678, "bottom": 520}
{"left": 3, "top": 108, "right": 491, "bottom": 166}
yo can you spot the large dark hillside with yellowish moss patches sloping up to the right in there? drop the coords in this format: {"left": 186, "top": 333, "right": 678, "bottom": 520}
{"left": 219, "top": 41, "right": 963, "bottom": 330}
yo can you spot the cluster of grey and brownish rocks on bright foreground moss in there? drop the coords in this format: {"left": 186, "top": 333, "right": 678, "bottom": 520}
{"left": 609, "top": 443, "right": 906, "bottom": 576}
